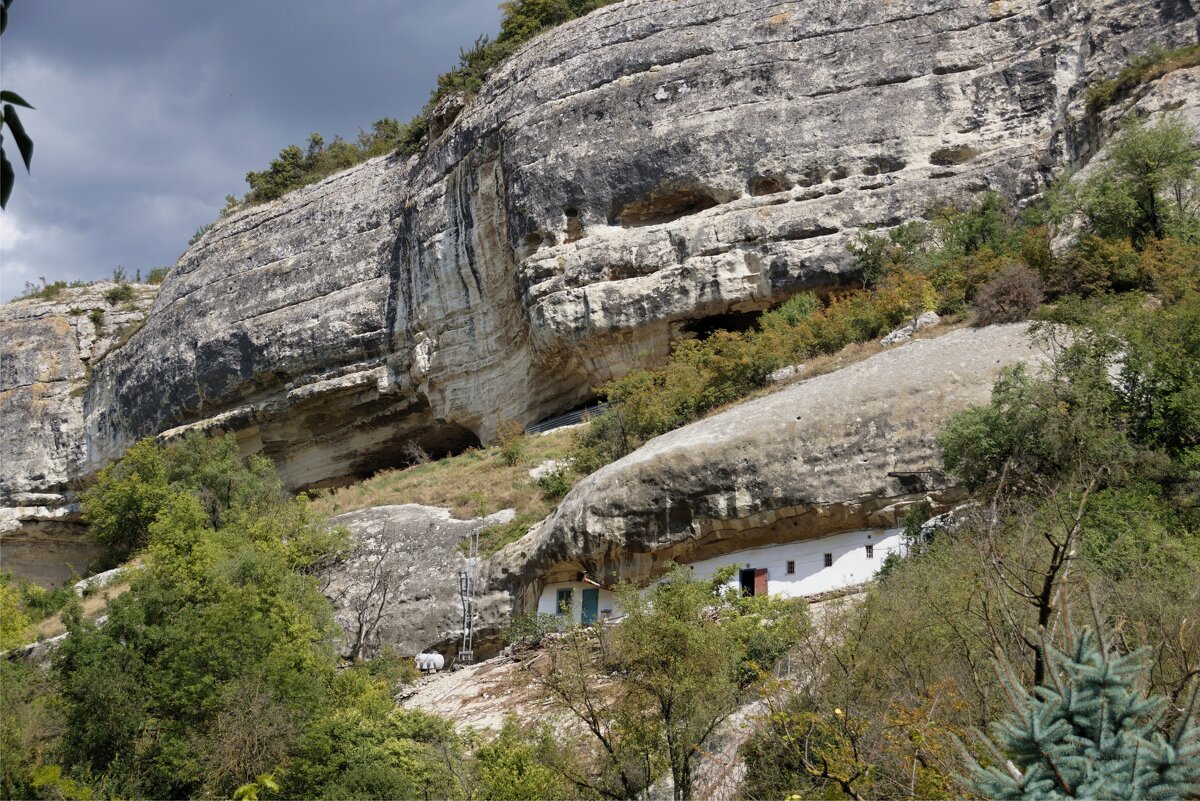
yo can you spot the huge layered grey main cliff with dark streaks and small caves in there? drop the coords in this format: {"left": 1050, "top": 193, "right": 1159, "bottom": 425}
{"left": 72, "top": 0, "right": 1196, "bottom": 494}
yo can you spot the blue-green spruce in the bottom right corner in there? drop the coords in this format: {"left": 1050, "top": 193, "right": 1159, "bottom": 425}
{"left": 965, "top": 606, "right": 1200, "bottom": 801}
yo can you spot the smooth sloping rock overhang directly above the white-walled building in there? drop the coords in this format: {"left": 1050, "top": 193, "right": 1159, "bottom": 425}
{"left": 487, "top": 324, "right": 1045, "bottom": 597}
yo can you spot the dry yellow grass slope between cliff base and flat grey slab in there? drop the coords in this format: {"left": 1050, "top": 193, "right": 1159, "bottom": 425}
{"left": 313, "top": 430, "right": 572, "bottom": 519}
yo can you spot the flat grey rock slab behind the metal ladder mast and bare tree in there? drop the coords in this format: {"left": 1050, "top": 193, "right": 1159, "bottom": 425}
{"left": 322, "top": 504, "right": 512, "bottom": 658}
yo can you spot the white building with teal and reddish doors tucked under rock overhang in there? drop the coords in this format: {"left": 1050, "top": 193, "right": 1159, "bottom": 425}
{"left": 538, "top": 529, "right": 902, "bottom": 625}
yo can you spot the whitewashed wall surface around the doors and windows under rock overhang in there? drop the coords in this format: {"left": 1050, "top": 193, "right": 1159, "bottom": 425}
{"left": 538, "top": 529, "right": 902, "bottom": 622}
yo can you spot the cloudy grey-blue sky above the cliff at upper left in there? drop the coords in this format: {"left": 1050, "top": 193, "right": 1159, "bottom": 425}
{"left": 0, "top": 0, "right": 499, "bottom": 300}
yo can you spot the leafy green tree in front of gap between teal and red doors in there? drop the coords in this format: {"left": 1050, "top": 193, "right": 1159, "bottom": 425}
{"left": 540, "top": 567, "right": 803, "bottom": 800}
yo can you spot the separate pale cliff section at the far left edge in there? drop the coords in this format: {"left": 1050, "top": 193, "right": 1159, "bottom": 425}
{"left": 0, "top": 282, "right": 156, "bottom": 584}
